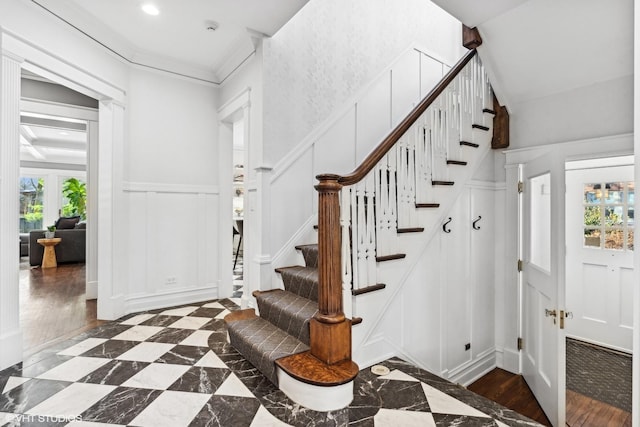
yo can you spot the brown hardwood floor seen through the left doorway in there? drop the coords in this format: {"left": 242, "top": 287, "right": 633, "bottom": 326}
{"left": 20, "top": 258, "right": 103, "bottom": 356}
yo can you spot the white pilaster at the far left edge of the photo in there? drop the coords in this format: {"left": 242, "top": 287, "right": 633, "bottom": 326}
{"left": 0, "top": 50, "right": 22, "bottom": 369}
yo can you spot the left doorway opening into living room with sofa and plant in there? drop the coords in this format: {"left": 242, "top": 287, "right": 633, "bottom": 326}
{"left": 18, "top": 70, "right": 100, "bottom": 356}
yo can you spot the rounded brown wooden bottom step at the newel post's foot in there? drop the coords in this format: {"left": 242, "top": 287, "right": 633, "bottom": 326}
{"left": 276, "top": 351, "right": 359, "bottom": 387}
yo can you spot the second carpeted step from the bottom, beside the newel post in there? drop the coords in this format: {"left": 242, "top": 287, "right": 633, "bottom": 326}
{"left": 256, "top": 289, "right": 318, "bottom": 344}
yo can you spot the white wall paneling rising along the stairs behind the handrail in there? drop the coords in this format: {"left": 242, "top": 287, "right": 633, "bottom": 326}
{"left": 270, "top": 47, "right": 449, "bottom": 267}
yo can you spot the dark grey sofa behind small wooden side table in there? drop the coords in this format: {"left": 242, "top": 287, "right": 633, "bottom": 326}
{"left": 29, "top": 217, "right": 87, "bottom": 266}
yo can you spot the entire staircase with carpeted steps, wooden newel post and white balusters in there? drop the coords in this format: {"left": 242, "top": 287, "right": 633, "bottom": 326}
{"left": 225, "top": 45, "right": 508, "bottom": 410}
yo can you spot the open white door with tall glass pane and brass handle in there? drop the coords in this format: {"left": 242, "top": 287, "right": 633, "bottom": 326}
{"left": 521, "top": 155, "right": 564, "bottom": 425}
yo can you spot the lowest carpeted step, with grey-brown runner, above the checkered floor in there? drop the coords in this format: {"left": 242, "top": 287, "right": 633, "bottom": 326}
{"left": 225, "top": 316, "right": 309, "bottom": 385}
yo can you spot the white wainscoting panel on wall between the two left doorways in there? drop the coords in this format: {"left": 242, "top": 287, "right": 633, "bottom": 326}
{"left": 123, "top": 182, "right": 219, "bottom": 312}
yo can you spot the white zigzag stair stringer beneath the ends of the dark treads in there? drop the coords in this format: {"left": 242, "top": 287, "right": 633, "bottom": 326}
{"left": 344, "top": 119, "right": 493, "bottom": 372}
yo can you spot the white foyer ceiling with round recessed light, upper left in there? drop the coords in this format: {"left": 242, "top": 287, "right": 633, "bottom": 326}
{"left": 31, "top": 0, "right": 308, "bottom": 83}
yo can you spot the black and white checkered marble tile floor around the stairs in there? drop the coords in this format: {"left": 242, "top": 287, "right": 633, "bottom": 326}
{"left": 0, "top": 299, "right": 537, "bottom": 427}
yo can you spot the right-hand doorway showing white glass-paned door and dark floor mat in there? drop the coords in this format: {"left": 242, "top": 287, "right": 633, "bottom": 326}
{"left": 565, "top": 156, "right": 635, "bottom": 426}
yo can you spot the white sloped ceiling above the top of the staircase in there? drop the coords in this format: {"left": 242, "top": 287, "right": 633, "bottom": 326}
{"left": 433, "top": 0, "right": 633, "bottom": 107}
